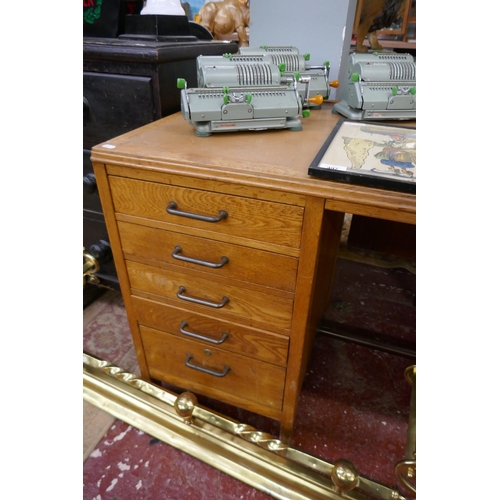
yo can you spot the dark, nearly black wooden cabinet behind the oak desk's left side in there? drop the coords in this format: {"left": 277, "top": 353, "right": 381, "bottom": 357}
{"left": 83, "top": 37, "right": 238, "bottom": 306}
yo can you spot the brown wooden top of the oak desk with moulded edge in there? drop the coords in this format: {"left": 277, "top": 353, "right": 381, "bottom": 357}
{"left": 91, "top": 103, "right": 416, "bottom": 223}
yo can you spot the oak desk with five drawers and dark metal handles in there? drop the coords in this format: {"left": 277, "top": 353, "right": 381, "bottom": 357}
{"left": 92, "top": 103, "right": 416, "bottom": 442}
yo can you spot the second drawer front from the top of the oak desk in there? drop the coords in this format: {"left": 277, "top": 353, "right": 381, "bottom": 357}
{"left": 118, "top": 222, "right": 298, "bottom": 292}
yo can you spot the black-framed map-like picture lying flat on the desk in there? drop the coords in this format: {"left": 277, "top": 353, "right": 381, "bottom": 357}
{"left": 308, "top": 118, "right": 417, "bottom": 194}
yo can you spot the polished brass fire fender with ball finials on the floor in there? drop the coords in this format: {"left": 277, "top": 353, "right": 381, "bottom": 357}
{"left": 83, "top": 353, "right": 416, "bottom": 500}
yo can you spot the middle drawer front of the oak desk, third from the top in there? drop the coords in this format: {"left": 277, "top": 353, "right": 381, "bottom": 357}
{"left": 127, "top": 261, "right": 293, "bottom": 330}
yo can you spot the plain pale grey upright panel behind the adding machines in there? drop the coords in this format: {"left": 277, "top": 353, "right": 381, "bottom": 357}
{"left": 250, "top": 0, "right": 356, "bottom": 99}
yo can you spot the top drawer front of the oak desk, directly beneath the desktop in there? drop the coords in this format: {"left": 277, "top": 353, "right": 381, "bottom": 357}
{"left": 109, "top": 176, "right": 304, "bottom": 248}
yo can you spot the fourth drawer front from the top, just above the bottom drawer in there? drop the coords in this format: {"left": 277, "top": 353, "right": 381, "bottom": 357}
{"left": 132, "top": 296, "right": 288, "bottom": 366}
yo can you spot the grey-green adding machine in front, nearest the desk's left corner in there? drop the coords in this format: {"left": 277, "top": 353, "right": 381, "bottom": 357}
{"left": 177, "top": 57, "right": 310, "bottom": 137}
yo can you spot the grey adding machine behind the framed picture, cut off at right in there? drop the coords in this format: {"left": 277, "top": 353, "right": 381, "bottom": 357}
{"left": 332, "top": 52, "right": 417, "bottom": 120}
